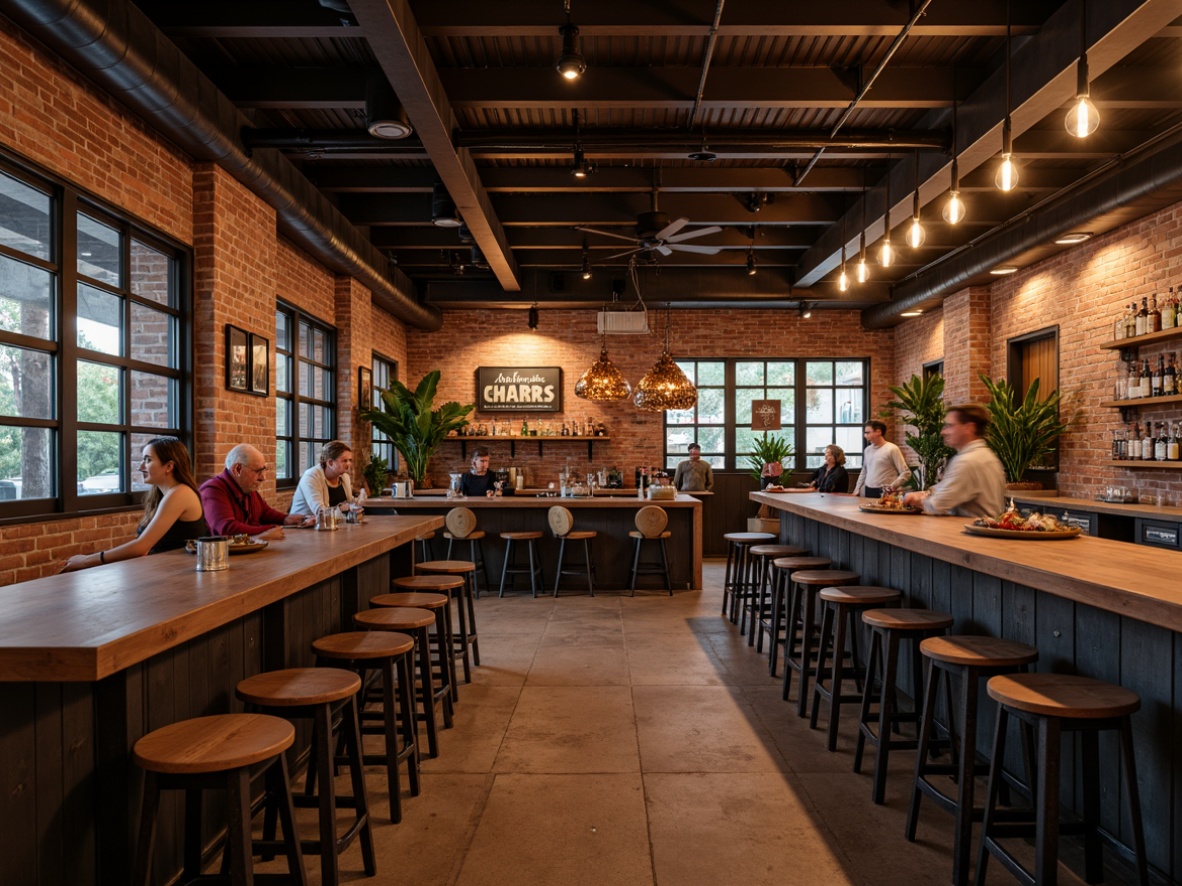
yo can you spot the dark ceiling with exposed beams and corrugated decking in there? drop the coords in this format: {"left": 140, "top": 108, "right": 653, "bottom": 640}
{"left": 137, "top": 0, "right": 1182, "bottom": 318}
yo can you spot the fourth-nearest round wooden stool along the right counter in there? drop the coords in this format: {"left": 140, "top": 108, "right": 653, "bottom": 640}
{"left": 808, "top": 585, "right": 903, "bottom": 750}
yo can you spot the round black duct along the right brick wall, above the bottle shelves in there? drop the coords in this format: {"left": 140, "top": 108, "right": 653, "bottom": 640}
{"left": 862, "top": 129, "right": 1182, "bottom": 330}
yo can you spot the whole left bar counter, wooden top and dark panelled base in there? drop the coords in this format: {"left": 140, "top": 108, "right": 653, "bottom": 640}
{"left": 0, "top": 514, "right": 443, "bottom": 886}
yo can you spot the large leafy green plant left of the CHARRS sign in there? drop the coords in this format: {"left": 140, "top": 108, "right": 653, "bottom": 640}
{"left": 361, "top": 370, "right": 475, "bottom": 488}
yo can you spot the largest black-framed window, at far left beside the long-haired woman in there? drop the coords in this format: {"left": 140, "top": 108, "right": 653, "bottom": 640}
{"left": 0, "top": 164, "right": 189, "bottom": 516}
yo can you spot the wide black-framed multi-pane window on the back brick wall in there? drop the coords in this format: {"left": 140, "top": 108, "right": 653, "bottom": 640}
{"left": 664, "top": 358, "right": 869, "bottom": 470}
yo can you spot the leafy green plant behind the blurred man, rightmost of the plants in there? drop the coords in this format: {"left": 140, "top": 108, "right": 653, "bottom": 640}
{"left": 981, "top": 374, "right": 1079, "bottom": 489}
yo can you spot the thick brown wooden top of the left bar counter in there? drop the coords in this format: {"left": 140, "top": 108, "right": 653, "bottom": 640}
{"left": 0, "top": 514, "right": 443, "bottom": 682}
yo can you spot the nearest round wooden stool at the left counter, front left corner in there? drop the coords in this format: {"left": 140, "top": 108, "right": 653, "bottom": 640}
{"left": 131, "top": 714, "right": 307, "bottom": 886}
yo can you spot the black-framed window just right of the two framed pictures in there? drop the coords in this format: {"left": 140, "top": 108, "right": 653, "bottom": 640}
{"left": 275, "top": 302, "right": 337, "bottom": 486}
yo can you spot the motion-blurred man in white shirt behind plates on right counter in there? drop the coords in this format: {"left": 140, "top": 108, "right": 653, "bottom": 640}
{"left": 903, "top": 403, "right": 1006, "bottom": 517}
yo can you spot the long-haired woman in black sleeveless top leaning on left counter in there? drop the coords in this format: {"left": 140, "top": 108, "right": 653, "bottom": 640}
{"left": 61, "top": 437, "right": 209, "bottom": 572}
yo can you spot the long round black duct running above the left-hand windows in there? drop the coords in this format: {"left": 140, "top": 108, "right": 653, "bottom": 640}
{"left": 6, "top": 0, "right": 442, "bottom": 330}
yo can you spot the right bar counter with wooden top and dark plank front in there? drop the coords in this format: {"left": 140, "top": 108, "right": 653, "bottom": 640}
{"left": 751, "top": 493, "right": 1182, "bottom": 882}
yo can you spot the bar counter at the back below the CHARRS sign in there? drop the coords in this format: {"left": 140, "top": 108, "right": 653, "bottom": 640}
{"left": 365, "top": 491, "right": 702, "bottom": 591}
